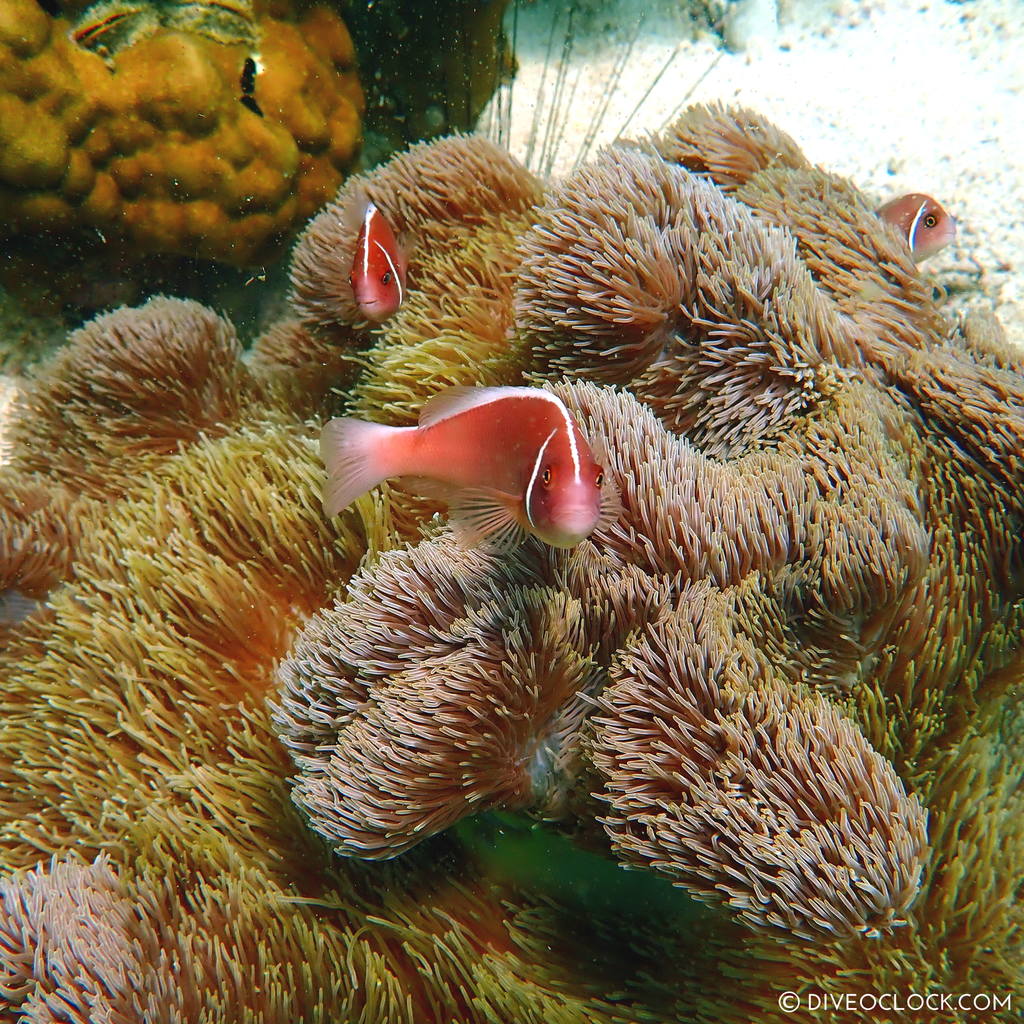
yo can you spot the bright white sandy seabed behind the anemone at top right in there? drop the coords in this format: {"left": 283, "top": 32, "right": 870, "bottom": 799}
{"left": 484, "top": 0, "right": 1024, "bottom": 344}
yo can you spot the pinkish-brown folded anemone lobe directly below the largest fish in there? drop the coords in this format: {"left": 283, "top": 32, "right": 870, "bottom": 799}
{"left": 276, "top": 538, "right": 597, "bottom": 857}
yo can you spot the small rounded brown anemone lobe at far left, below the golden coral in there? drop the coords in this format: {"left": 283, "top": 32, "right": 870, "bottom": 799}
{"left": 11, "top": 297, "right": 248, "bottom": 496}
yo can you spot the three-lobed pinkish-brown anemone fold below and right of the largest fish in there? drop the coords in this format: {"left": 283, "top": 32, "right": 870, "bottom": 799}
{"left": 278, "top": 384, "right": 928, "bottom": 935}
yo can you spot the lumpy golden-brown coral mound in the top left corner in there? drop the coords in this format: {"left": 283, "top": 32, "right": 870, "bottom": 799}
{"left": 0, "top": 0, "right": 362, "bottom": 264}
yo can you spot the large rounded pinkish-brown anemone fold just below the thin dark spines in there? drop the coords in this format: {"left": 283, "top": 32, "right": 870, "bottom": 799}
{"left": 516, "top": 150, "right": 859, "bottom": 455}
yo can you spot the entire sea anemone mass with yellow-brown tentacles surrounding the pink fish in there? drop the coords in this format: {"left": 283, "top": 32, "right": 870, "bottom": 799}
{"left": 0, "top": 108, "right": 1024, "bottom": 1024}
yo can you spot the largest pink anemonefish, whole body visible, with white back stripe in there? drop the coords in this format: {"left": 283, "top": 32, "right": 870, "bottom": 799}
{"left": 321, "top": 387, "right": 604, "bottom": 548}
